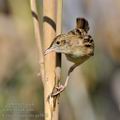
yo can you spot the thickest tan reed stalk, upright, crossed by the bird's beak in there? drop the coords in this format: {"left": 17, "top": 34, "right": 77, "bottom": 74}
{"left": 43, "top": 0, "right": 58, "bottom": 120}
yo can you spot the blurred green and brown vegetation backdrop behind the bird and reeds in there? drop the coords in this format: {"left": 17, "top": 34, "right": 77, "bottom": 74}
{"left": 0, "top": 0, "right": 120, "bottom": 120}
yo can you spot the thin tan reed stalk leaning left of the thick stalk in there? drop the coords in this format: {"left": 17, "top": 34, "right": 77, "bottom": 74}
{"left": 30, "top": 0, "right": 45, "bottom": 85}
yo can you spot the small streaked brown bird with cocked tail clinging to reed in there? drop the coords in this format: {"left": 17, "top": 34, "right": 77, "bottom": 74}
{"left": 45, "top": 18, "right": 94, "bottom": 96}
